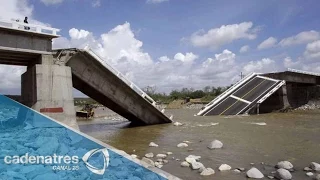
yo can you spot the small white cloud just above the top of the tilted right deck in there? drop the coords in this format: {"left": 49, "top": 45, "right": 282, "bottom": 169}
{"left": 243, "top": 58, "right": 280, "bottom": 74}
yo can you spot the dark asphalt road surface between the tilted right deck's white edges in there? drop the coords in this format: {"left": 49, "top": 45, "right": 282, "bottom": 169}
{"left": 206, "top": 76, "right": 277, "bottom": 115}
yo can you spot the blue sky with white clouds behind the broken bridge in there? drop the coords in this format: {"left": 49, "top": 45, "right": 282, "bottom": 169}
{"left": 0, "top": 0, "right": 320, "bottom": 94}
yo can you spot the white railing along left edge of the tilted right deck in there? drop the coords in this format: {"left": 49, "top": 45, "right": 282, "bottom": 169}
{"left": 197, "top": 73, "right": 257, "bottom": 116}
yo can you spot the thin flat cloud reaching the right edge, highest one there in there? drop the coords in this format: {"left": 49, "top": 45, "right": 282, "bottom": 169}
{"left": 279, "top": 30, "right": 320, "bottom": 46}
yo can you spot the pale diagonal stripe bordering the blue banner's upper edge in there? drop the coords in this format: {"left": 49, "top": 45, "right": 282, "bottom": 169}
{"left": 16, "top": 99, "right": 181, "bottom": 180}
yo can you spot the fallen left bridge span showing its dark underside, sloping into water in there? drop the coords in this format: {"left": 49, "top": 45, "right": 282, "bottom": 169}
{"left": 55, "top": 48, "right": 172, "bottom": 125}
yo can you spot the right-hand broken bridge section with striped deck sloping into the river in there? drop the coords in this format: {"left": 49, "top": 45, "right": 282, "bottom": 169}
{"left": 197, "top": 69, "right": 320, "bottom": 116}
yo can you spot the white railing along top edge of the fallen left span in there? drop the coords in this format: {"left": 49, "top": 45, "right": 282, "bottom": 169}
{"left": 84, "top": 46, "right": 156, "bottom": 106}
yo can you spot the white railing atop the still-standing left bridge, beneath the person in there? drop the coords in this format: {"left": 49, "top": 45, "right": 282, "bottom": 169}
{"left": 0, "top": 19, "right": 60, "bottom": 36}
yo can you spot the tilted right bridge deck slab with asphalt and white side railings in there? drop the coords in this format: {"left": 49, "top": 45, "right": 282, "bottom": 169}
{"left": 197, "top": 73, "right": 285, "bottom": 116}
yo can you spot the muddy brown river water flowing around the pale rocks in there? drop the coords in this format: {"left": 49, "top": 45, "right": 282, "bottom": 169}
{"left": 79, "top": 109, "right": 320, "bottom": 180}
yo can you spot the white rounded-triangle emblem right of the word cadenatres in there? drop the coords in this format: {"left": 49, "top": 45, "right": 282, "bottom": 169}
{"left": 82, "top": 148, "right": 109, "bottom": 175}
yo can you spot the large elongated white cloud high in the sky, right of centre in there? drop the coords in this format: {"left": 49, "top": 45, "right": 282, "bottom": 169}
{"left": 190, "top": 22, "right": 257, "bottom": 48}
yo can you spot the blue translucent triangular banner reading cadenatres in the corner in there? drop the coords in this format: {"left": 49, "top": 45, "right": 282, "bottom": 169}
{"left": 0, "top": 95, "right": 166, "bottom": 180}
